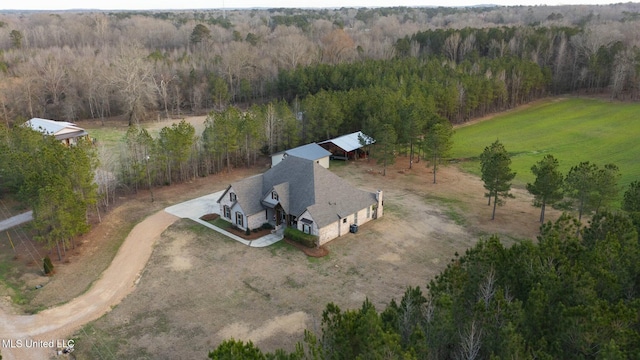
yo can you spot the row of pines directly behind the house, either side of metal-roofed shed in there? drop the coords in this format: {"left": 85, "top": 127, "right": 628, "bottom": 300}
{"left": 117, "top": 92, "right": 453, "bottom": 191}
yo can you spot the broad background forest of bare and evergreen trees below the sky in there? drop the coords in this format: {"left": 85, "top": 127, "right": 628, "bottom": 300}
{"left": 0, "top": 3, "right": 640, "bottom": 134}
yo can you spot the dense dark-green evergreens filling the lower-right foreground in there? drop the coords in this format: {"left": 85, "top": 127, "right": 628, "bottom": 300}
{"left": 209, "top": 210, "right": 640, "bottom": 359}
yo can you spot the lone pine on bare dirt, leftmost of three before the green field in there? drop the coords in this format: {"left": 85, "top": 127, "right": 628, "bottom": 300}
{"left": 480, "top": 140, "right": 516, "bottom": 220}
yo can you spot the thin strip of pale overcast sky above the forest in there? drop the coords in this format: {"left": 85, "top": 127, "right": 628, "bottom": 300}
{"left": 0, "top": 0, "right": 614, "bottom": 10}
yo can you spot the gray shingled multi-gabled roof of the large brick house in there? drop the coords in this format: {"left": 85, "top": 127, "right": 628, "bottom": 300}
{"left": 223, "top": 156, "right": 376, "bottom": 227}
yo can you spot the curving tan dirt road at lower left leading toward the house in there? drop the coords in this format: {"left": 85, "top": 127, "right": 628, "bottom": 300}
{"left": 0, "top": 211, "right": 178, "bottom": 359}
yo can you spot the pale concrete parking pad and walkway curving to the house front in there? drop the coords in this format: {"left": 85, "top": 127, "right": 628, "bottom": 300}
{"left": 164, "top": 191, "right": 284, "bottom": 247}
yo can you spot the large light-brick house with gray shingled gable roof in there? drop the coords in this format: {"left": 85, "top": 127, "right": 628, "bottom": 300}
{"left": 217, "top": 156, "right": 383, "bottom": 245}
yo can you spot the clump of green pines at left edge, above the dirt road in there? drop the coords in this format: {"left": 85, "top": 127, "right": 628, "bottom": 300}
{"left": 0, "top": 125, "right": 99, "bottom": 259}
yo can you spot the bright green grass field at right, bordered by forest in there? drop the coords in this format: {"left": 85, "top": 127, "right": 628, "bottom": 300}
{"left": 452, "top": 98, "right": 640, "bottom": 194}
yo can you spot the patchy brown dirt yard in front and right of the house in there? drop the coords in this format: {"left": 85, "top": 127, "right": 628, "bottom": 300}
{"left": 66, "top": 162, "right": 553, "bottom": 359}
